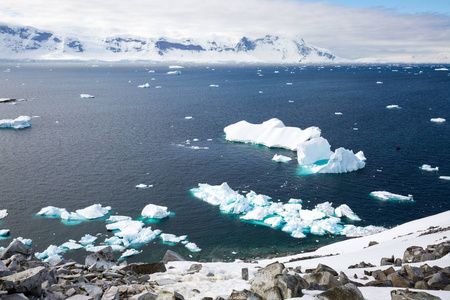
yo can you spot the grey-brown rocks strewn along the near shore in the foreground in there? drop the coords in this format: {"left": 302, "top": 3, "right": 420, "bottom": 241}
{"left": 0, "top": 240, "right": 450, "bottom": 300}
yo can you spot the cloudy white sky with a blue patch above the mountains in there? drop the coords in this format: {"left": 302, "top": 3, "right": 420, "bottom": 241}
{"left": 0, "top": 0, "right": 450, "bottom": 59}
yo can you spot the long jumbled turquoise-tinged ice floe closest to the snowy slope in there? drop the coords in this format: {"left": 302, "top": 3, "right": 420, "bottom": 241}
{"left": 191, "top": 182, "right": 384, "bottom": 238}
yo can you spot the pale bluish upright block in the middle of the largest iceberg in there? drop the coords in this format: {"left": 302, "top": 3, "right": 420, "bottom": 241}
{"left": 297, "top": 137, "right": 333, "bottom": 165}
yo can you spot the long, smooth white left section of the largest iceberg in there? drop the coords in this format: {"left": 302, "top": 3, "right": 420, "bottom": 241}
{"left": 224, "top": 118, "right": 320, "bottom": 151}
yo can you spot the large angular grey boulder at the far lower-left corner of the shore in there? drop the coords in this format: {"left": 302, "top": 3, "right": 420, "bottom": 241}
{"left": 0, "top": 267, "right": 48, "bottom": 294}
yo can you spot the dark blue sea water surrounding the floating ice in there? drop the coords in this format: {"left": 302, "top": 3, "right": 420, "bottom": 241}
{"left": 0, "top": 62, "right": 450, "bottom": 262}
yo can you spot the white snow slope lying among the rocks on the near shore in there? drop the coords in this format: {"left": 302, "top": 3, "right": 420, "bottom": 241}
{"left": 152, "top": 211, "right": 450, "bottom": 300}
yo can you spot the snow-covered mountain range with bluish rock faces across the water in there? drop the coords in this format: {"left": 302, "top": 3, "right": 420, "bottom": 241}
{"left": 0, "top": 25, "right": 336, "bottom": 63}
